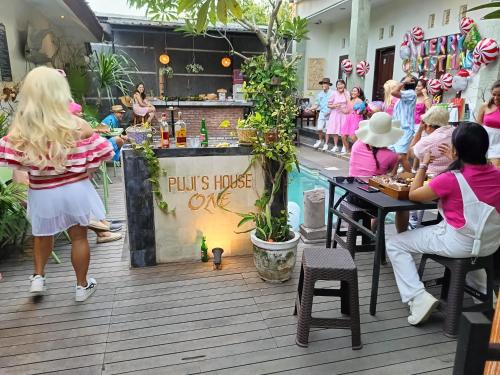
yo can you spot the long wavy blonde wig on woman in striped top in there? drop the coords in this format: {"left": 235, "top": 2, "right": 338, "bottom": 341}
{"left": 9, "top": 66, "right": 77, "bottom": 171}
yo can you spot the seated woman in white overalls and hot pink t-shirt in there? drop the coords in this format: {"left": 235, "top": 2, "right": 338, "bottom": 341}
{"left": 387, "top": 122, "right": 500, "bottom": 325}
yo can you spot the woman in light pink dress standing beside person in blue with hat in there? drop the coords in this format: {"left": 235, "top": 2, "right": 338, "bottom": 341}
{"left": 323, "top": 79, "right": 350, "bottom": 152}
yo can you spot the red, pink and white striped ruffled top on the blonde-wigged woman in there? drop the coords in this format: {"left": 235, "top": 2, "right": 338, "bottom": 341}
{"left": 0, "top": 133, "right": 114, "bottom": 189}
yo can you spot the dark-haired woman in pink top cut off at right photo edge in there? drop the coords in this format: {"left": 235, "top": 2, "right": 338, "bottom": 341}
{"left": 478, "top": 81, "right": 500, "bottom": 168}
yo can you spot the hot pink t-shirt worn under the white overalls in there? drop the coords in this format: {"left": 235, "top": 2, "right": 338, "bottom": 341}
{"left": 429, "top": 164, "right": 500, "bottom": 228}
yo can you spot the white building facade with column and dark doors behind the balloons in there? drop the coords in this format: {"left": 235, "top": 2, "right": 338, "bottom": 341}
{"left": 296, "top": 0, "right": 500, "bottom": 114}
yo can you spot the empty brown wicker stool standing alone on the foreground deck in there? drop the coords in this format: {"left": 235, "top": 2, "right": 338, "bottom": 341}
{"left": 294, "top": 248, "right": 363, "bottom": 350}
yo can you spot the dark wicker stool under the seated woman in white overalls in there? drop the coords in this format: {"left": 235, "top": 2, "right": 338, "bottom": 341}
{"left": 418, "top": 254, "right": 494, "bottom": 337}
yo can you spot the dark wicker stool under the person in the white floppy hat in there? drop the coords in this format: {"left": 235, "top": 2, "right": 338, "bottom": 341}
{"left": 333, "top": 201, "right": 376, "bottom": 261}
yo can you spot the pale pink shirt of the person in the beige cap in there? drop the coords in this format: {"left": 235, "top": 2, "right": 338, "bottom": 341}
{"left": 413, "top": 126, "right": 453, "bottom": 175}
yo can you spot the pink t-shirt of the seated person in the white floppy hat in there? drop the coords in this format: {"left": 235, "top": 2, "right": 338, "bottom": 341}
{"left": 349, "top": 140, "right": 398, "bottom": 177}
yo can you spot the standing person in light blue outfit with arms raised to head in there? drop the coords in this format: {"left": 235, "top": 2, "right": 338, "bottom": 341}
{"left": 391, "top": 76, "right": 418, "bottom": 172}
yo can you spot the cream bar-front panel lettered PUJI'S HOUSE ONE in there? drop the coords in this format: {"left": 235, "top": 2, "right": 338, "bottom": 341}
{"left": 154, "top": 155, "right": 264, "bottom": 263}
